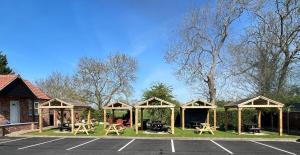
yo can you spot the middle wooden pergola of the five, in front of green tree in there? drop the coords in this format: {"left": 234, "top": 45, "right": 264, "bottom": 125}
{"left": 134, "top": 97, "right": 175, "bottom": 134}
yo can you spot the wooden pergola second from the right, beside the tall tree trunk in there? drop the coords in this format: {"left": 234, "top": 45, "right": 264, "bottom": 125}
{"left": 180, "top": 100, "right": 217, "bottom": 130}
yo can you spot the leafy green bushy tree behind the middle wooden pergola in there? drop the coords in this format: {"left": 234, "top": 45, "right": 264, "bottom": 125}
{"left": 143, "top": 83, "right": 180, "bottom": 123}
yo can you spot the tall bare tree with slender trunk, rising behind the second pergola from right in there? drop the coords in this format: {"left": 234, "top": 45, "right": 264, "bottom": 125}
{"left": 165, "top": 0, "right": 244, "bottom": 104}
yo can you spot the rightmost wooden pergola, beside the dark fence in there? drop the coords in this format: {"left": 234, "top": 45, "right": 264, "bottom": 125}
{"left": 224, "top": 96, "right": 284, "bottom": 136}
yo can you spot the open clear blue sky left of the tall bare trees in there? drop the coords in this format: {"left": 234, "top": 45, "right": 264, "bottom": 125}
{"left": 0, "top": 0, "right": 209, "bottom": 102}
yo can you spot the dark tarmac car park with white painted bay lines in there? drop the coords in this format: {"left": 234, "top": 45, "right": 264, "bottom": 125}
{"left": 0, "top": 137, "right": 300, "bottom": 155}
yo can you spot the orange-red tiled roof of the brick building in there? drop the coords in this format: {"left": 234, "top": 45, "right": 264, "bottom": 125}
{"left": 0, "top": 75, "right": 51, "bottom": 100}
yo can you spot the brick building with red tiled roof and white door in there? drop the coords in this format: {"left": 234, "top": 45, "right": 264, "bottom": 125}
{"left": 0, "top": 75, "right": 50, "bottom": 125}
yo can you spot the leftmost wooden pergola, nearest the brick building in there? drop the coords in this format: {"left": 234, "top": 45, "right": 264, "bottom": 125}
{"left": 38, "top": 98, "right": 91, "bottom": 133}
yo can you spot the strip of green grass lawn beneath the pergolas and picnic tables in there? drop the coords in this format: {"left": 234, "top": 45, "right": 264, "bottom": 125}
{"left": 25, "top": 125, "right": 300, "bottom": 139}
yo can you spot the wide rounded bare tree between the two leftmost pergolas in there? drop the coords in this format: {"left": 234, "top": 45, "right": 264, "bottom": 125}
{"left": 75, "top": 54, "right": 137, "bottom": 109}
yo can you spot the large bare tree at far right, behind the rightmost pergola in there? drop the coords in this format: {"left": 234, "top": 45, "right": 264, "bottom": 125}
{"left": 231, "top": 0, "right": 300, "bottom": 95}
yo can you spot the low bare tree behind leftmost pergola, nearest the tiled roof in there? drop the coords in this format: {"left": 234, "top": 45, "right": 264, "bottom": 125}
{"left": 36, "top": 72, "right": 82, "bottom": 100}
